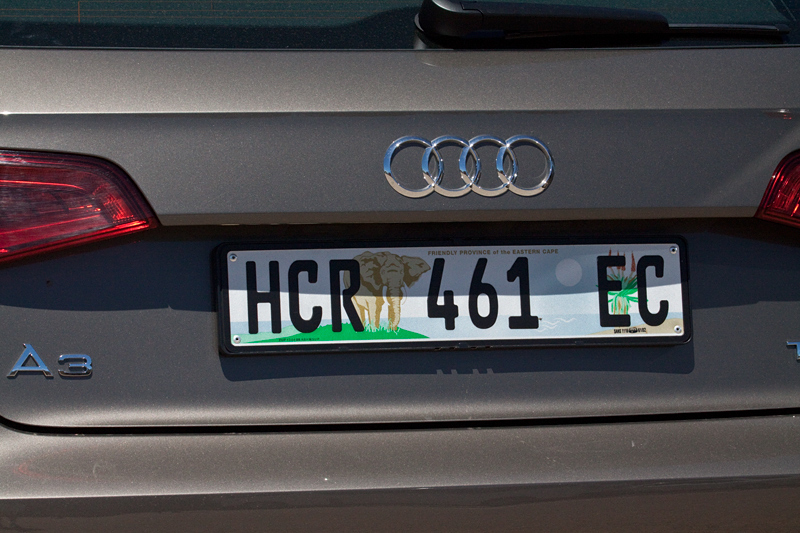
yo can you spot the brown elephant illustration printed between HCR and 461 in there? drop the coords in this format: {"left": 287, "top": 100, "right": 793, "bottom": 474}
{"left": 344, "top": 252, "right": 431, "bottom": 331}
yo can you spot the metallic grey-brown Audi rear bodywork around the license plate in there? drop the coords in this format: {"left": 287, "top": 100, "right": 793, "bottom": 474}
{"left": 0, "top": 47, "right": 800, "bottom": 531}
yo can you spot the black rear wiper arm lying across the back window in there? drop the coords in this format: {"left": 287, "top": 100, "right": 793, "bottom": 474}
{"left": 416, "top": 0, "right": 789, "bottom": 43}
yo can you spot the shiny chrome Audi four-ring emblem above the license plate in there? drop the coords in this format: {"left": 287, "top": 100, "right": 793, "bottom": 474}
{"left": 383, "top": 135, "right": 553, "bottom": 198}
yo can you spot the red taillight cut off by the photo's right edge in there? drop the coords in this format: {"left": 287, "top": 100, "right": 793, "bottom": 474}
{"left": 756, "top": 150, "right": 800, "bottom": 227}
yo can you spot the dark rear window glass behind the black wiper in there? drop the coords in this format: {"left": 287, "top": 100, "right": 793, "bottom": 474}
{"left": 0, "top": 0, "right": 800, "bottom": 49}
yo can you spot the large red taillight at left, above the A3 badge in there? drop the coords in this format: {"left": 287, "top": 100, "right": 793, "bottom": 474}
{"left": 0, "top": 151, "right": 156, "bottom": 262}
